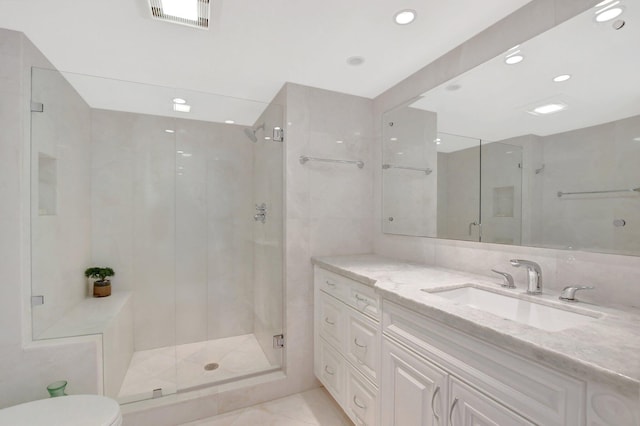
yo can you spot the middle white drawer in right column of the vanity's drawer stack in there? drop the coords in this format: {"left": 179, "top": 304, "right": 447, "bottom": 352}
{"left": 345, "top": 308, "right": 380, "bottom": 383}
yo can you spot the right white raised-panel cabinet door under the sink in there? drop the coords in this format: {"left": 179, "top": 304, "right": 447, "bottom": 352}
{"left": 447, "top": 377, "right": 534, "bottom": 426}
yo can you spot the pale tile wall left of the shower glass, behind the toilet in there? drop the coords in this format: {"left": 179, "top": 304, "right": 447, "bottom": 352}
{"left": 0, "top": 30, "right": 101, "bottom": 407}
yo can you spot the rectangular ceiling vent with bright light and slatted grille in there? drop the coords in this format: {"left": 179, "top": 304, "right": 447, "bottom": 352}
{"left": 149, "top": 0, "right": 210, "bottom": 29}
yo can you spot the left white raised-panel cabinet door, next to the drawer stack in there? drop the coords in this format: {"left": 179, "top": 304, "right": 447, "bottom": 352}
{"left": 380, "top": 338, "right": 448, "bottom": 426}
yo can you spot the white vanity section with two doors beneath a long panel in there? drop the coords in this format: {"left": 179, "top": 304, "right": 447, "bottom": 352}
{"left": 380, "top": 300, "right": 586, "bottom": 426}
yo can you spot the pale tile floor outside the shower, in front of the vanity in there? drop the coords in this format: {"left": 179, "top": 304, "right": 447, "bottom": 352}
{"left": 182, "top": 388, "right": 353, "bottom": 426}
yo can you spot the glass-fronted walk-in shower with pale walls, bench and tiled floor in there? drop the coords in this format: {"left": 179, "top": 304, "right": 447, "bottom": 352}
{"left": 31, "top": 68, "right": 284, "bottom": 403}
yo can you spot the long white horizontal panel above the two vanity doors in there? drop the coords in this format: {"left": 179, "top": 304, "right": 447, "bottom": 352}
{"left": 383, "top": 301, "right": 586, "bottom": 426}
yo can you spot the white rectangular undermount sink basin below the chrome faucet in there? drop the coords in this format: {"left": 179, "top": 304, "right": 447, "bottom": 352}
{"left": 423, "top": 285, "right": 599, "bottom": 331}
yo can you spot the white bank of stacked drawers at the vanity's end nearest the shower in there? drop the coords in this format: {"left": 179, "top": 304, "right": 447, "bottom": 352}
{"left": 314, "top": 267, "right": 381, "bottom": 426}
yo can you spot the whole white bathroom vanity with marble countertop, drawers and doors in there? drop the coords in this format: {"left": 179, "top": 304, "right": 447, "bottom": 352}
{"left": 313, "top": 255, "right": 640, "bottom": 426}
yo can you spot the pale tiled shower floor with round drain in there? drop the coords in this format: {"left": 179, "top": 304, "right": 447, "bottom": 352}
{"left": 118, "top": 334, "right": 275, "bottom": 403}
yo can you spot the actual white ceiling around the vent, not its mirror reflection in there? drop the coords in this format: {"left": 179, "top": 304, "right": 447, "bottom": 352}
{"left": 0, "top": 0, "right": 530, "bottom": 120}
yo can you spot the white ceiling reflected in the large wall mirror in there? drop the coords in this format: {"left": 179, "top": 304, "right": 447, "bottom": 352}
{"left": 412, "top": 1, "right": 640, "bottom": 141}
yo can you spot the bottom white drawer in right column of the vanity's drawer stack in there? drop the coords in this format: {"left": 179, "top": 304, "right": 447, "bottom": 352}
{"left": 345, "top": 368, "right": 378, "bottom": 426}
